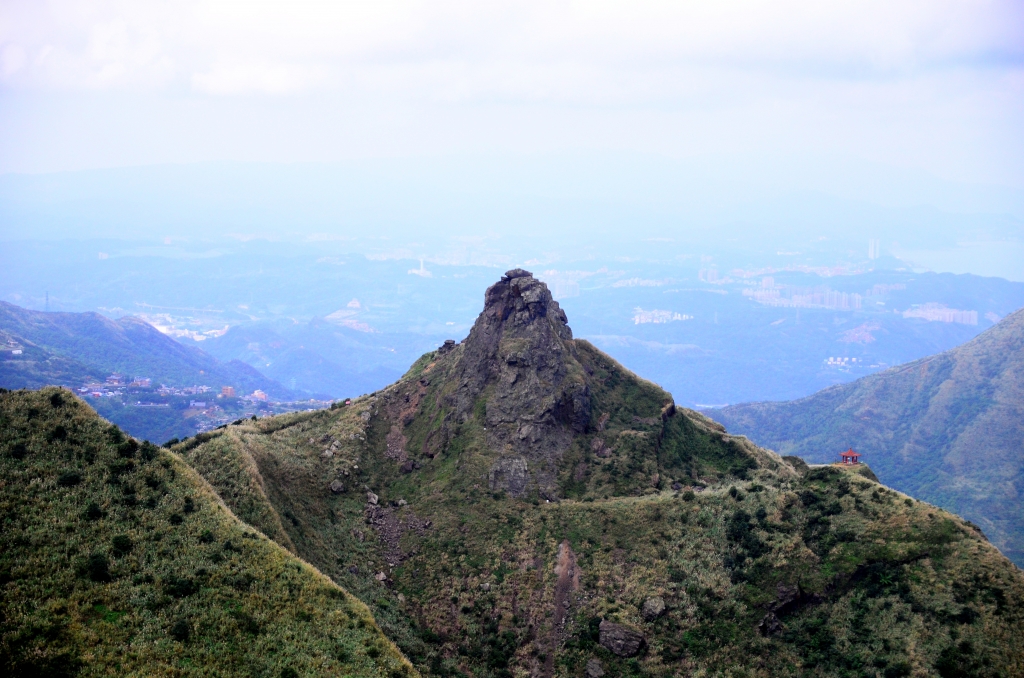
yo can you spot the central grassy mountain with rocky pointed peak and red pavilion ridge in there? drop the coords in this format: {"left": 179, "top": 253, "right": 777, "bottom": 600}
{"left": 175, "top": 270, "right": 1024, "bottom": 678}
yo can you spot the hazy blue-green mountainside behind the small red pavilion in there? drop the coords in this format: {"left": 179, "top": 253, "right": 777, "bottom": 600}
{"left": 715, "top": 310, "right": 1024, "bottom": 566}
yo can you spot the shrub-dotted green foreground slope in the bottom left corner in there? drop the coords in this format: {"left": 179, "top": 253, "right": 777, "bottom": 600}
{"left": 0, "top": 388, "right": 415, "bottom": 678}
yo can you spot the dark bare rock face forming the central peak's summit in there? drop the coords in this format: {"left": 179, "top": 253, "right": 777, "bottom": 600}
{"left": 451, "top": 268, "right": 591, "bottom": 497}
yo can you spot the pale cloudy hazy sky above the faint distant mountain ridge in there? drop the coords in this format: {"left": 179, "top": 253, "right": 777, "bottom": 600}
{"left": 0, "top": 0, "right": 1024, "bottom": 188}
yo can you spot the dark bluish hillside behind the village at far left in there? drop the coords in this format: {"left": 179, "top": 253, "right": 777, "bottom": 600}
{"left": 0, "top": 301, "right": 299, "bottom": 399}
